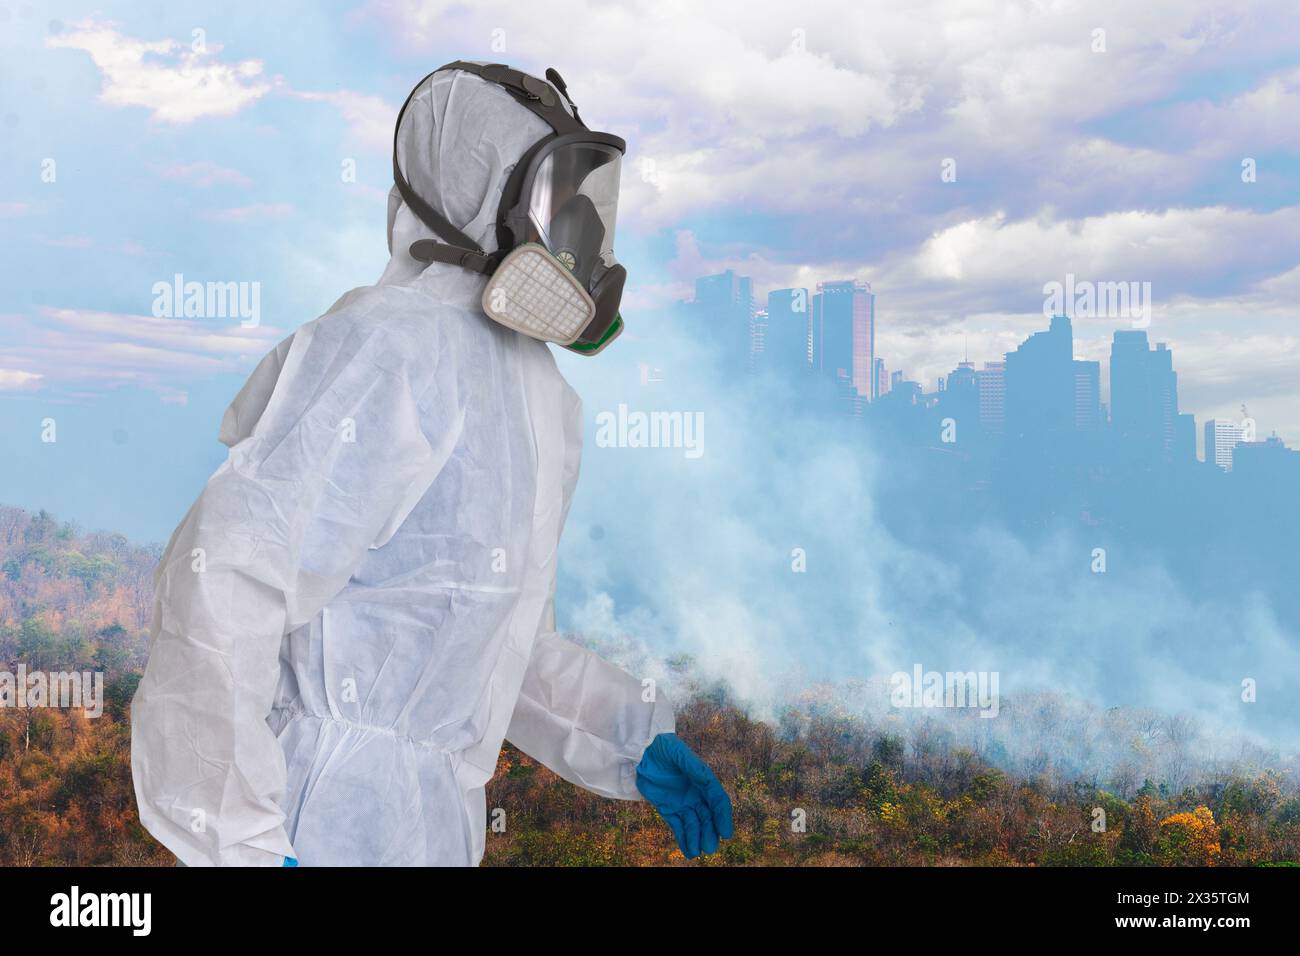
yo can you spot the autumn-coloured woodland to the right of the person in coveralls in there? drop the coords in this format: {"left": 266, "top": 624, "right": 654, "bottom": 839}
{"left": 485, "top": 691, "right": 1300, "bottom": 866}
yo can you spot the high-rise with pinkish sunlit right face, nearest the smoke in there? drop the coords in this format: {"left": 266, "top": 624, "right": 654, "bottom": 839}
{"left": 811, "top": 280, "right": 876, "bottom": 398}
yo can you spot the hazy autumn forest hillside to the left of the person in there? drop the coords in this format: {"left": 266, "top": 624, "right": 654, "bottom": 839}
{"left": 0, "top": 507, "right": 165, "bottom": 866}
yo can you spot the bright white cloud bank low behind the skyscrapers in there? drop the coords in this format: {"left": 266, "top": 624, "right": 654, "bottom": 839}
{"left": 660, "top": 206, "right": 1300, "bottom": 444}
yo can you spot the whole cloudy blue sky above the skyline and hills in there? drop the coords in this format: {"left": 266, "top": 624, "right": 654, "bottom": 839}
{"left": 0, "top": 0, "right": 1300, "bottom": 538}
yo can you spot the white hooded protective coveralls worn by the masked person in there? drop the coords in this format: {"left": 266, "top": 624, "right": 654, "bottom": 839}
{"left": 131, "top": 72, "right": 673, "bottom": 866}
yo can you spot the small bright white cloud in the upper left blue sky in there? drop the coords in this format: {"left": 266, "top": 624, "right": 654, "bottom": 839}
{"left": 46, "top": 20, "right": 273, "bottom": 125}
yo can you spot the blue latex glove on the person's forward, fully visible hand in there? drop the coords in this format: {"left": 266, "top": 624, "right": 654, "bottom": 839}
{"left": 637, "top": 734, "right": 732, "bottom": 860}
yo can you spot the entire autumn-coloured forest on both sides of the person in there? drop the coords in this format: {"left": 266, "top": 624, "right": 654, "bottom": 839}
{"left": 0, "top": 507, "right": 1300, "bottom": 866}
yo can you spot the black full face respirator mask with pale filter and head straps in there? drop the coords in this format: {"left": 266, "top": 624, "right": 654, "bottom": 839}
{"left": 393, "top": 60, "right": 628, "bottom": 355}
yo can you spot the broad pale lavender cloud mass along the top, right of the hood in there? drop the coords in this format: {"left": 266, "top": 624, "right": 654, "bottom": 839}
{"left": 365, "top": 0, "right": 1300, "bottom": 231}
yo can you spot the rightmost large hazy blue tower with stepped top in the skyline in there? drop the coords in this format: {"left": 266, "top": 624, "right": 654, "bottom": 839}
{"left": 1110, "top": 329, "right": 1195, "bottom": 460}
